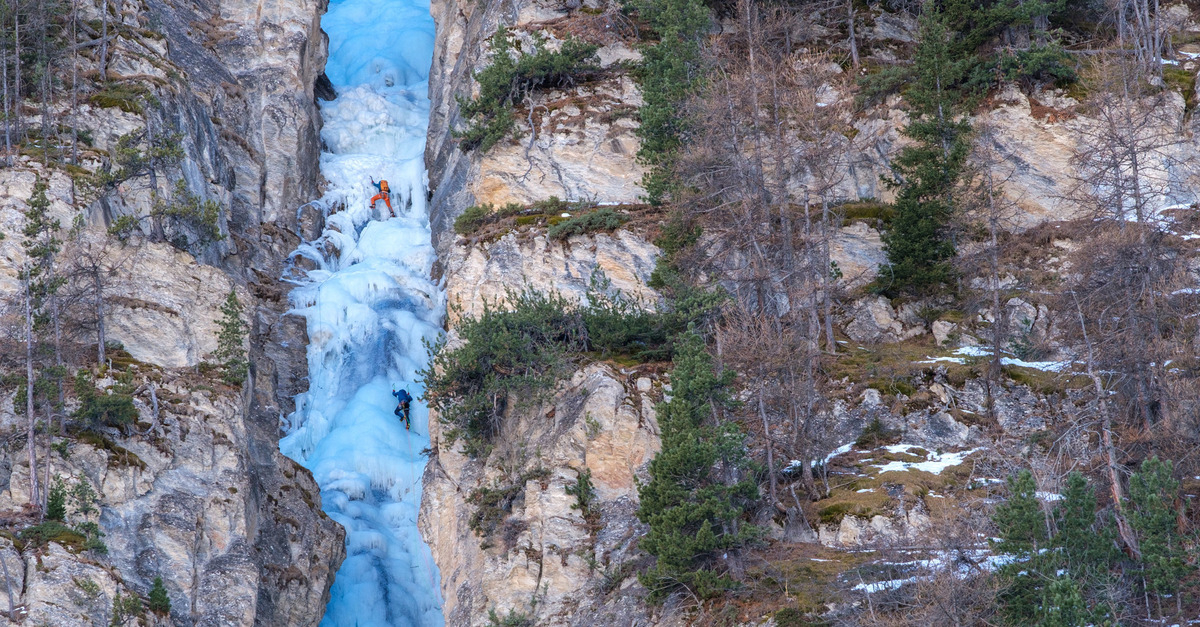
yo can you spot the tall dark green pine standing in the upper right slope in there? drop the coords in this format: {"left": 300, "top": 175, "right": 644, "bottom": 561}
{"left": 880, "top": 8, "right": 970, "bottom": 294}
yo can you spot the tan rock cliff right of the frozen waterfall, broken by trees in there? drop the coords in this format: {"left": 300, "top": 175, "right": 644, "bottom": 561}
{"left": 420, "top": 0, "right": 1198, "bottom": 626}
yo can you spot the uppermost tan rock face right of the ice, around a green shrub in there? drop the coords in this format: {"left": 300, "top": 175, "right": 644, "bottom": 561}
{"left": 425, "top": 0, "right": 642, "bottom": 256}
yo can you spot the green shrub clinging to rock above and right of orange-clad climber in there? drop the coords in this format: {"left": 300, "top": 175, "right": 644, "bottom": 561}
{"left": 455, "top": 26, "right": 599, "bottom": 153}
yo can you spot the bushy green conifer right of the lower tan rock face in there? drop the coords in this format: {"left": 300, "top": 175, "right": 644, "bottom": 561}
{"left": 637, "top": 333, "right": 758, "bottom": 599}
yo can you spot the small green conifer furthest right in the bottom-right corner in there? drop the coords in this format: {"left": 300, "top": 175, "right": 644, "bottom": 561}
{"left": 1129, "top": 455, "right": 1195, "bottom": 596}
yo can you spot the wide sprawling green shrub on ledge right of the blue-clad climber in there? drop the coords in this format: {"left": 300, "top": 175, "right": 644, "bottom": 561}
{"left": 421, "top": 273, "right": 724, "bottom": 456}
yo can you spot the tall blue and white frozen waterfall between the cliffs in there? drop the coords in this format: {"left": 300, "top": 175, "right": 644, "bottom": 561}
{"left": 280, "top": 0, "right": 445, "bottom": 627}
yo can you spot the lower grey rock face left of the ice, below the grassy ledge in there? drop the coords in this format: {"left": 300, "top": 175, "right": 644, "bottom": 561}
{"left": 0, "top": 371, "right": 344, "bottom": 626}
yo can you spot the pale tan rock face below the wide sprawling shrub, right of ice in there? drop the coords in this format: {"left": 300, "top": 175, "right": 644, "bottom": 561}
{"left": 420, "top": 364, "right": 661, "bottom": 626}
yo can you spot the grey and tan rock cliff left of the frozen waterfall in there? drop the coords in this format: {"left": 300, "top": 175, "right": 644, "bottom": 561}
{"left": 0, "top": 0, "right": 343, "bottom": 614}
